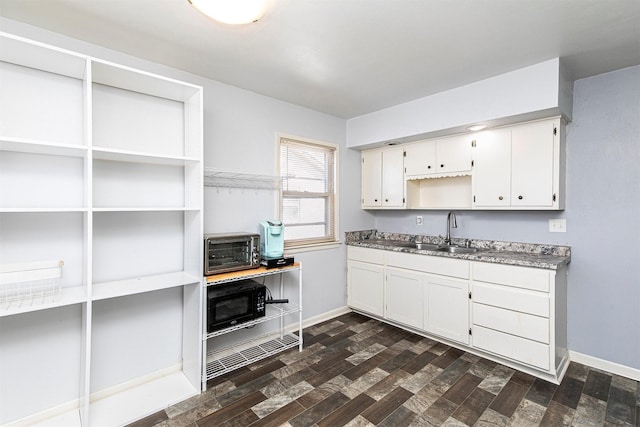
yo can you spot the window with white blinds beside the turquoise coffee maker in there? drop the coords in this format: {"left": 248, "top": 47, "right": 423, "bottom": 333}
{"left": 280, "top": 137, "right": 338, "bottom": 248}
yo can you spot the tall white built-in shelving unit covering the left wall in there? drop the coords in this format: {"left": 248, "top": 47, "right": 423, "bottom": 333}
{"left": 0, "top": 33, "right": 203, "bottom": 426}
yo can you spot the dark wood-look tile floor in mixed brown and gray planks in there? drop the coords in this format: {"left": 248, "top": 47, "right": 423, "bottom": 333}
{"left": 131, "top": 313, "right": 640, "bottom": 427}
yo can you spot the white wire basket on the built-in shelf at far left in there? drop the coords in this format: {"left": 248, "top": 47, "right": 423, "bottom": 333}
{"left": 0, "top": 261, "right": 64, "bottom": 310}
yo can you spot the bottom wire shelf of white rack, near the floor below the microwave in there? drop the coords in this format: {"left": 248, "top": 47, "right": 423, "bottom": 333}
{"left": 207, "top": 334, "right": 300, "bottom": 380}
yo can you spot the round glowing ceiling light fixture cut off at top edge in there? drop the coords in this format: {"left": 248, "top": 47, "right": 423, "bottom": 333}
{"left": 187, "top": 0, "right": 267, "bottom": 25}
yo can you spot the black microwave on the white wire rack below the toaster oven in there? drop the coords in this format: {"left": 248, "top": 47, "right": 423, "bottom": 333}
{"left": 207, "top": 279, "right": 266, "bottom": 333}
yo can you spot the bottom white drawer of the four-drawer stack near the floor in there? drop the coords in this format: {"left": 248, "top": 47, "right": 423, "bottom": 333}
{"left": 472, "top": 326, "right": 550, "bottom": 371}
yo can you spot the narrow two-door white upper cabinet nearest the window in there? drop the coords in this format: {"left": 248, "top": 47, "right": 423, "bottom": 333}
{"left": 361, "top": 147, "right": 405, "bottom": 209}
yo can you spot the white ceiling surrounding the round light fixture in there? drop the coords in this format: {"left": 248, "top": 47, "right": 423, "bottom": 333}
{"left": 0, "top": 0, "right": 640, "bottom": 118}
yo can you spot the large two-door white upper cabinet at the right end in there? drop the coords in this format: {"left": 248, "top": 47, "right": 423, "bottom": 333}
{"left": 472, "top": 118, "right": 564, "bottom": 210}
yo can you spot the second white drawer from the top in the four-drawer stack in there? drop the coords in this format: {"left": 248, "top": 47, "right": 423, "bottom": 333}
{"left": 471, "top": 282, "right": 550, "bottom": 317}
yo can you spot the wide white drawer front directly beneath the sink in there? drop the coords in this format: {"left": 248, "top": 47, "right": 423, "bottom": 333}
{"left": 387, "top": 252, "right": 469, "bottom": 279}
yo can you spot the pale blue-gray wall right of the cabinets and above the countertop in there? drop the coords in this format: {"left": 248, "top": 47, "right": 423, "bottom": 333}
{"left": 376, "top": 66, "right": 640, "bottom": 369}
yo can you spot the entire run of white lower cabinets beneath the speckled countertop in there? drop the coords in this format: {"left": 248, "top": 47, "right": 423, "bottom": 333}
{"left": 347, "top": 246, "right": 569, "bottom": 383}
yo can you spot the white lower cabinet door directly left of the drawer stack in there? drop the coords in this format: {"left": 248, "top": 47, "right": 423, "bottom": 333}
{"left": 423, "top": 276, "right": 469, "bottom": 344}
